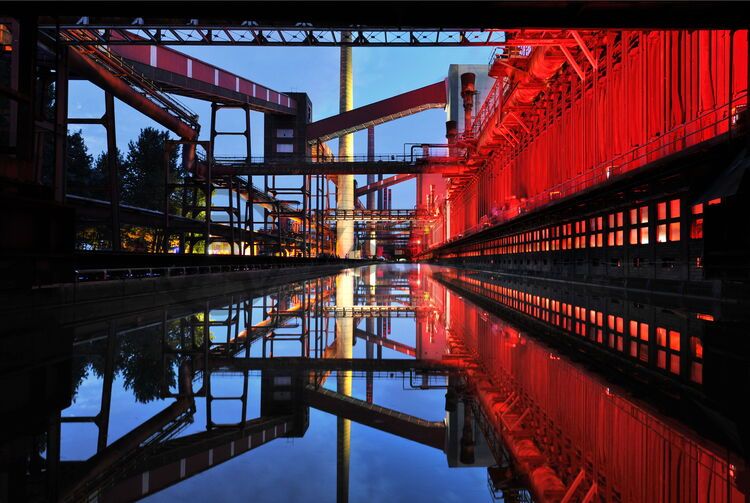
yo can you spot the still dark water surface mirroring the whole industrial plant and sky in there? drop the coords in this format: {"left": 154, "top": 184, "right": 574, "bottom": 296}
{"left": 2, "top": 265, "right": 747, "bottom": 502}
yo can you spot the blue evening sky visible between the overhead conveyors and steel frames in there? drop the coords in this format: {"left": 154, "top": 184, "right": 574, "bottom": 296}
{"left": 69, "top": 47, "right": 492, "bottom": 208}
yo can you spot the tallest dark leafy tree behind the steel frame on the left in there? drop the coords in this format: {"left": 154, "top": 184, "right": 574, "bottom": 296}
{"left": 122, "top": 127, "right": 183, "bottom": 210}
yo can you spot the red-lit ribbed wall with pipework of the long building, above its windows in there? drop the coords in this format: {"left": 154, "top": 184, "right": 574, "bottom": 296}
{"left": 424, "top": 30, "right": 748, "bottom": 246}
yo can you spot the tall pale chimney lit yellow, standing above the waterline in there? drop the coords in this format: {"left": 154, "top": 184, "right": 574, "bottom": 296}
{"left": 336, "top": 32, "right": 354, "bottom": 258}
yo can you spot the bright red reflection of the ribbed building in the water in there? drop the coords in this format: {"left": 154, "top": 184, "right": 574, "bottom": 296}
{"left": 429, "top": 266, "right": 748, "bottom": 502}
